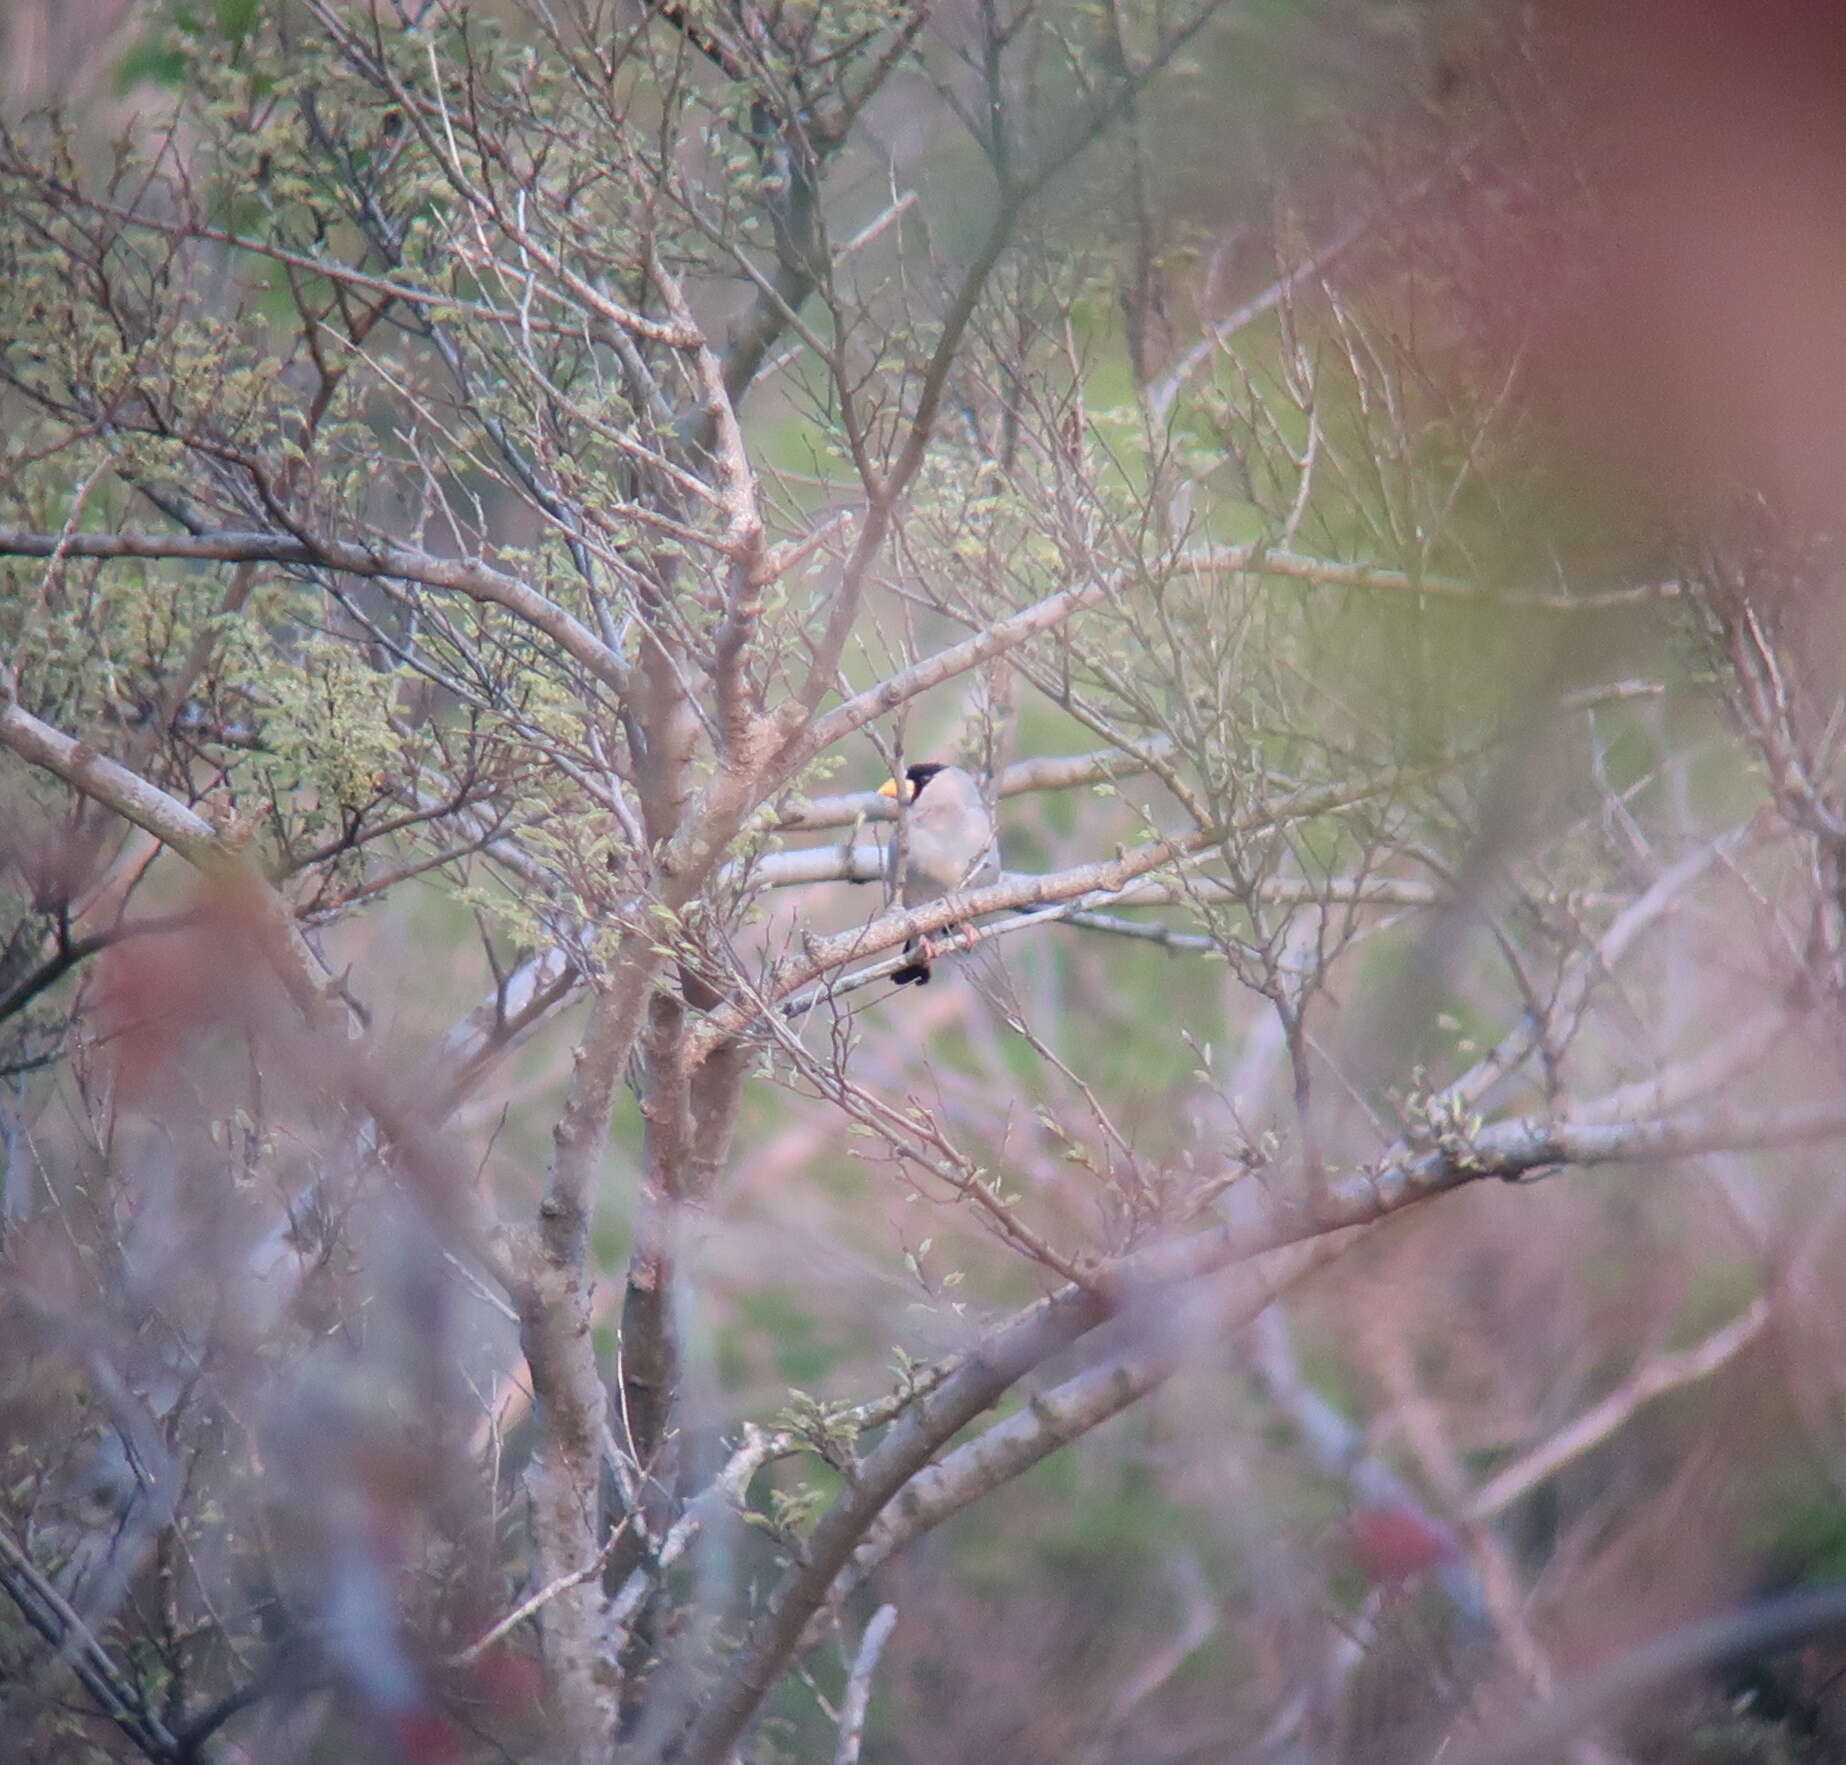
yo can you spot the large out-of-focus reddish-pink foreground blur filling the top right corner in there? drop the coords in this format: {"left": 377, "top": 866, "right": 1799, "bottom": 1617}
{"left": 1503, "top": 0, "right": 1846, "bottom": 521}
